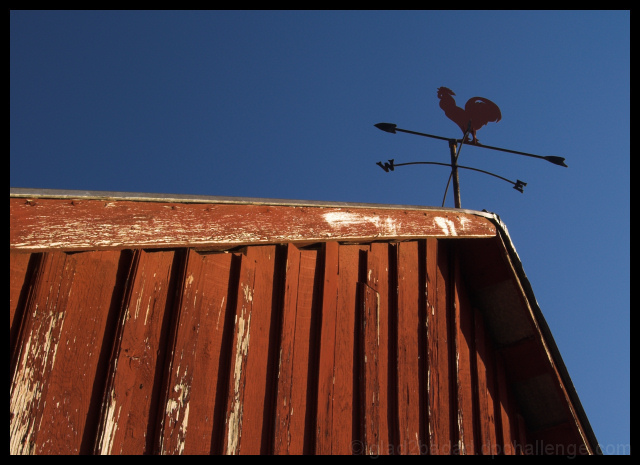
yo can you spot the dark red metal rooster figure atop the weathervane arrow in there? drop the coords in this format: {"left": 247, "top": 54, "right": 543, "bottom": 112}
{"left": 438, "top": 87, "right": 502, "bottom": 145}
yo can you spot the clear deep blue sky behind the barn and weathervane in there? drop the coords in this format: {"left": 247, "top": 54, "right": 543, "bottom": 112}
{"left": 10, "top": 11, "right": 630, "bottom": 453}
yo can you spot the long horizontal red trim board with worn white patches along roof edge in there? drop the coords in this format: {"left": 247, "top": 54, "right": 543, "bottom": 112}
{"left": 9, "top": 198, "right": 496, "bottom": 251}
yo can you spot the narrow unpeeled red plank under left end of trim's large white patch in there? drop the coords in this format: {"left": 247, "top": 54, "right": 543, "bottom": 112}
{"left": 315, "top": 242, "right": 339, "bottom": 455}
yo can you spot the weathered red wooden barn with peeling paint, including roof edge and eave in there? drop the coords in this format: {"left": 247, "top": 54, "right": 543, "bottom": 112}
{"left": 10, "top": 189, "right": 601, "bottom": 455}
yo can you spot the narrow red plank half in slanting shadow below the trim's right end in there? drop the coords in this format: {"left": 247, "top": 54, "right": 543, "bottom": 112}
{"left": 454, "top": 253, "right": 476, "bottom": 455}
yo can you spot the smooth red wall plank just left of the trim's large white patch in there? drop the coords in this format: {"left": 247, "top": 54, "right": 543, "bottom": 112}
{"left": 274, "top": 244, "right": 317, "bottom": 455}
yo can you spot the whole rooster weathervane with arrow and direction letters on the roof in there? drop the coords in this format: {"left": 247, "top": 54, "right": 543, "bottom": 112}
{"left": 375, "top": 87, "right": 567, "bottom": 208}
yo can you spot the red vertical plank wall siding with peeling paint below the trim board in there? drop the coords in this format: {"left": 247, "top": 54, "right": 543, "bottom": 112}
{"left": 10, "top": 239, "right": 526, "bottom": 454}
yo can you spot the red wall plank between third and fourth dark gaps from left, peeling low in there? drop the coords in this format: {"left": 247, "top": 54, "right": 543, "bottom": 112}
{"left": 160, "top": 251, "right": 237, "bottom": 454}
